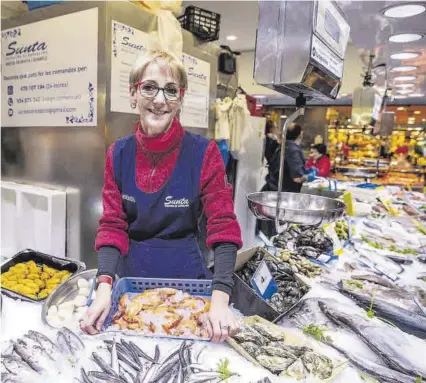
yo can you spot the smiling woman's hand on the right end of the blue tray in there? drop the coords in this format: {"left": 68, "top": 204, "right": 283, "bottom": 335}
{"left": 207, "top": 290, "right": 238, "bottom": 342}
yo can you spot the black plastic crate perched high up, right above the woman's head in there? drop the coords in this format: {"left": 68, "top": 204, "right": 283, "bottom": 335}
{"left": 179, "top": 5, "right": 220, "bottom": 42}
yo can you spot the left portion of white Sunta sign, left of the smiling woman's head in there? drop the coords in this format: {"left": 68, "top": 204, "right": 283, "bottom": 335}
{"left": 111, "top": 20, "right": 151, "bottom": 114}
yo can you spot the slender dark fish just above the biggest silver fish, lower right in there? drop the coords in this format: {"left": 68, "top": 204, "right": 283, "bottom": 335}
{"left": 342, "top": 284, "right": 426, "bottom": 339}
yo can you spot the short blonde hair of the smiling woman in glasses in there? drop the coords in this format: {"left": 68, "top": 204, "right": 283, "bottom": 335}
{"left": 129, "top": 50, "right": 188, "bottom": 91}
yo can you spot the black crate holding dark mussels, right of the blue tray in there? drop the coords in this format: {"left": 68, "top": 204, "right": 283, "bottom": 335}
{"left": 231, "top": 246, "right": 310, "bottom": 323}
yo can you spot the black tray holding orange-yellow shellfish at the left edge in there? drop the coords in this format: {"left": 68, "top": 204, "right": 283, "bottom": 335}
{"left": 1, "top": 249, "right": 86, "bottom": 303}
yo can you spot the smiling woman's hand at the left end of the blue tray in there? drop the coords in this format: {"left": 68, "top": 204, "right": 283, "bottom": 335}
{"left": 80, "top": 283, "right": 112, "bottom": 335}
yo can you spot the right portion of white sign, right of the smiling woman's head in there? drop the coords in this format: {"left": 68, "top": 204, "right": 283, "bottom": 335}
{"left": 180, "top": 54, "right": 210, "bottom": 129}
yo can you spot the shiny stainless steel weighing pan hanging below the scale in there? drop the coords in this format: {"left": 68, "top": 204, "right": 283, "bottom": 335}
{"left": 247, "top": 192, "right": 346, "bottom": 226}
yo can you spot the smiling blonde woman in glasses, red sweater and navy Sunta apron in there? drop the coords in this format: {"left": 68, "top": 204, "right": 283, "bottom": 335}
{"left": 80, "top": 51, "right": 242, "bottom": 341}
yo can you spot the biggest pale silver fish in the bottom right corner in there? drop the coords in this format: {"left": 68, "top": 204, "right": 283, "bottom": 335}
{"left": 318, "top": 301, "right": 426, "bottom": 379}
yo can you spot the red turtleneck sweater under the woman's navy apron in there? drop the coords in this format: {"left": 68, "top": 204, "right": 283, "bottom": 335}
{"left": 95, "top": 120, "right": 242, "bottom": 255}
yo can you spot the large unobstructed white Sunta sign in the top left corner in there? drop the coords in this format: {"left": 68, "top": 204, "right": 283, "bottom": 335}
{"left": 1, "top": 8, "right": 98, "bottom": 126}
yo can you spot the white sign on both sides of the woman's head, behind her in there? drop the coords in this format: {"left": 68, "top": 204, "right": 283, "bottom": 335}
{"left": 111, "top": 20, "right": 210, "bottom": 128}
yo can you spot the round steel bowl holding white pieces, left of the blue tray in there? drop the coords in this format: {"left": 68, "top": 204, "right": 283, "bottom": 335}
{"left": 41, "top": 269, "right": 98, "bottom": 328}
